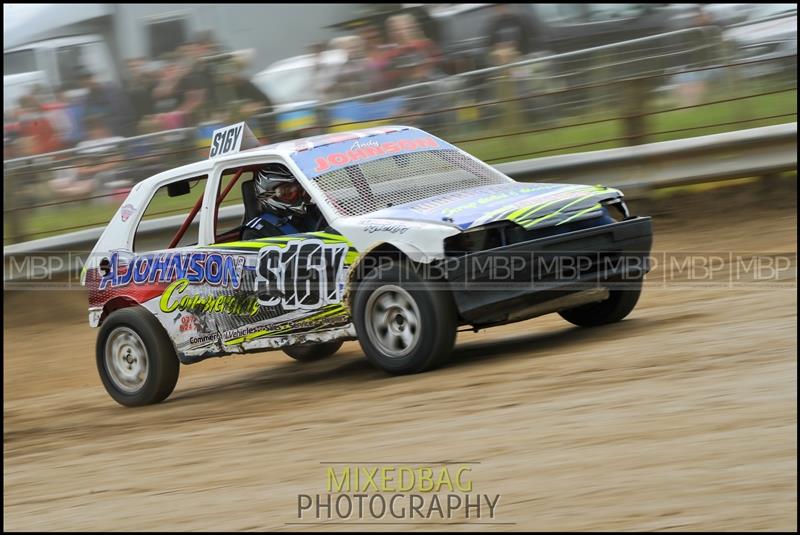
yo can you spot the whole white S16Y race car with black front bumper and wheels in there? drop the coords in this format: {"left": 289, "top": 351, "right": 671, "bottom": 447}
{"left": 81, "top": 123, "right": 652, "bottom": 406}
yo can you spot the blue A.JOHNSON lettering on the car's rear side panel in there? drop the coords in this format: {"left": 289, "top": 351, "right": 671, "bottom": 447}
{"left": 99, "top": 252, "right": 245, "bottom": 290}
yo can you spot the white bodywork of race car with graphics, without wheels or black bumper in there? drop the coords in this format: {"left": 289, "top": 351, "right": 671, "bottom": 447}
{"left": 82, "top": 126, "right": 650, "bottom": 363}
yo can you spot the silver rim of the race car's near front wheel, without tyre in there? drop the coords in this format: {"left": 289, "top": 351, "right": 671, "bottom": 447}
{"left": 364, "top": 285, "right": 420, "bottom": 358}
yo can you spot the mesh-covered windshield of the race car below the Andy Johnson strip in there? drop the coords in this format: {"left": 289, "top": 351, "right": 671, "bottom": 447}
{"left": 313, "top": 149, "right": 511, "bottom": 216}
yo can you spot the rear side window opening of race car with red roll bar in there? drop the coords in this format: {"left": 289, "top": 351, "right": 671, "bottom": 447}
{"left": 133, "top": 175, "right": 208, "bottom": 253}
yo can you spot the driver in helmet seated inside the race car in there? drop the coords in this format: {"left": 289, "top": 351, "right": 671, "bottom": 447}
{"left": 242, "top": 169, "right": 322, "bottom": 240}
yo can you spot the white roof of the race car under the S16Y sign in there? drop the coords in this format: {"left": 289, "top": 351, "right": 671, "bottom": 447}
{"left": 142, "top": 125, "right": 420, "bottom": 184}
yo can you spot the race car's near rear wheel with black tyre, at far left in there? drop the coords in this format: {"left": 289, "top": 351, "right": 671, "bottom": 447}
{"left": 96, "top": 306, "right": 180, "bottom": 407}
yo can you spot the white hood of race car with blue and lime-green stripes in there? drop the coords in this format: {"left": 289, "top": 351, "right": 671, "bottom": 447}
{"left": 364, "top": 182, "right": 622, "bottom": 230}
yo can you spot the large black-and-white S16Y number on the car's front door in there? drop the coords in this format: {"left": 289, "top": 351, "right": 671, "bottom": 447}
{"left": 256, "top": 240, "right": 349, "bottom": 310}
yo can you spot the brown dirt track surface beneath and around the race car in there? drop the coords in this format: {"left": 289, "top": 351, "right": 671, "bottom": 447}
{"left": 3, "top": 185, "right": 797, "bottom": 530}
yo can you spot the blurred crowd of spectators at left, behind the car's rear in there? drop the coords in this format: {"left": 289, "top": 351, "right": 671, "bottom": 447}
{"left": 4, "top": 32, "right": 272, "bottom": 159}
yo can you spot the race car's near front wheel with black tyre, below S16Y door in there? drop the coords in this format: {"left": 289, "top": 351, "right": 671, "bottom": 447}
{"left": 352, "top": 260, "right": 458, "bottom": 375}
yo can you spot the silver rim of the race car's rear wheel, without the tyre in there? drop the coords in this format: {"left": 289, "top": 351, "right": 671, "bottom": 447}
{"left": 105, "top": 327, "right": 149, "bottom": 394}
